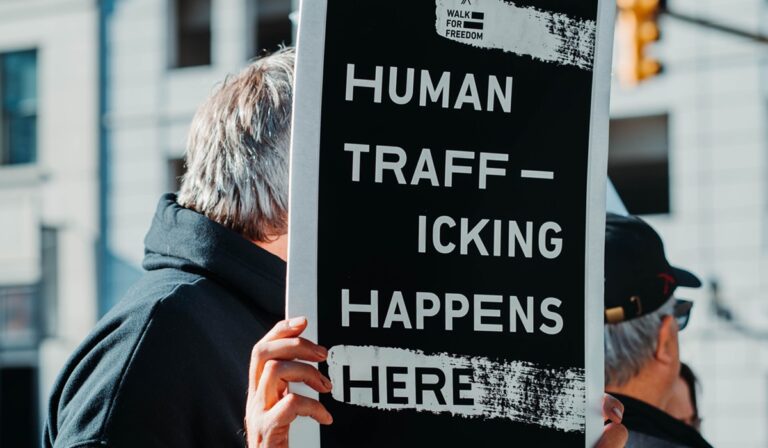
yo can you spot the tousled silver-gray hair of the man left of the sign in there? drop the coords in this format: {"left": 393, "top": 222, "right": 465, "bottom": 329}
{"left": 178, "top": 48, "right": 295, "bottom": 241}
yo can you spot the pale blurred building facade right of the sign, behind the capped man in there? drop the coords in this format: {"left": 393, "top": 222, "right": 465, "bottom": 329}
{"left": 609, "top": 0, "right": 768, "bottom": 448}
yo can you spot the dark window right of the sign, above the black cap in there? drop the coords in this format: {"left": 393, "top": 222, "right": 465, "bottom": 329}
{"left": 608, "top": 114, "right": 670, "bottom": 215}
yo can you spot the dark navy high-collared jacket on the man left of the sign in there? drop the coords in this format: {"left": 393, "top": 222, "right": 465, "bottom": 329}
{"left": 43, "top": 195, "right": 286, "bottom": 448}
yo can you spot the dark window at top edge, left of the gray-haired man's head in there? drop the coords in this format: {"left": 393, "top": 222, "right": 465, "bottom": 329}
{"left": 170, "top": 0, "right": 211, "bottom": 68}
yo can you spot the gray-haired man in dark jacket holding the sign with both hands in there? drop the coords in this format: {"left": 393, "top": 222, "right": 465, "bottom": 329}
{"left": 43, "top": 49, "right": 626, "bottom": 448}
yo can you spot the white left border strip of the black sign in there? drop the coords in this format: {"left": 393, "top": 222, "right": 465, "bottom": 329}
{"left": 285, "top": 0, "right": 328, "bottom": 448}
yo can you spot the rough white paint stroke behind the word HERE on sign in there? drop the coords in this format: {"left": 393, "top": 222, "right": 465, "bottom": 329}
{"left": 328, "top": 345, "right": 586, "bottom": 433}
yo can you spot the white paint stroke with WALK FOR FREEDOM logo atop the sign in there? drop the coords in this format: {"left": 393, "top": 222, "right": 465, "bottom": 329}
{"left": 436, "top": 0, "right": 597, "bottom": 70}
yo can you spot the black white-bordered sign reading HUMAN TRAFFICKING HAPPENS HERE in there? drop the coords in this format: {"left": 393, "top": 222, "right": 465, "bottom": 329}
{"left": 287, "top": 0, "right": 613, "bottom": 448}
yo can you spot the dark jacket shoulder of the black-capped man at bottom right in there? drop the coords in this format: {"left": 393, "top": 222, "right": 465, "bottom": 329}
{"left": 612, "top": 394, "right": 712, "bottom": 448}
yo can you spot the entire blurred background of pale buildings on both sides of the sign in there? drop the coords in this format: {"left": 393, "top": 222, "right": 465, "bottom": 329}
{"left": 0, "top": 0, "right": 768, "bottom": 448}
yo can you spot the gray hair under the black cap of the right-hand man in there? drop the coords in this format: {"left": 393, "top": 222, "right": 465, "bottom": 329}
{"left": 604, "top": 297, "right": 675, "bottom": 386}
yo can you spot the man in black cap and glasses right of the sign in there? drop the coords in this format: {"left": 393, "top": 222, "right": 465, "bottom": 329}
{"left": 605, "top": 213, "right": 711, "bottom": 448}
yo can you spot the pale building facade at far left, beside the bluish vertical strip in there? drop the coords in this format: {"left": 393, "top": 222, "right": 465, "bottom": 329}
{"left": 0, "top": 0, "right": 99, "bottom": 447}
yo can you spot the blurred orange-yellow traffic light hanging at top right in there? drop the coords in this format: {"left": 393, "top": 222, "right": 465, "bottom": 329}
{"left": 617, "top": 0, "right": 663, "bottom": 85}
